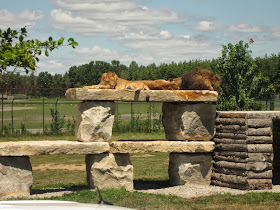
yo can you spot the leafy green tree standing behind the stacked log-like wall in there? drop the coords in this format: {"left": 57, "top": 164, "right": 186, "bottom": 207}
{"left": 217, "top": 39, "right": 274, "bottom": 110}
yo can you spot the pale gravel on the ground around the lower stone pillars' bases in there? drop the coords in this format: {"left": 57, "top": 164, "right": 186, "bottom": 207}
{"left": 26, "top": 185, "right": 280, "bottom": 199}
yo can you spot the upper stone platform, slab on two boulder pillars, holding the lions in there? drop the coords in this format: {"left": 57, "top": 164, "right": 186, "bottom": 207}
{"left": 65, "top": 88, "right": 218, "bottom": 142}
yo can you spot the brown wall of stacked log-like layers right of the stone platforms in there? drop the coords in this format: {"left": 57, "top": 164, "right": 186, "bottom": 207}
{"left": 211, "top": 112, "right": 280, "bottom": 190}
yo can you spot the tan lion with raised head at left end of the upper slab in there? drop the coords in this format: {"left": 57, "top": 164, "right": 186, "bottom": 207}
{"left": 84, "top": 72, "right": 150, "bottom": 90}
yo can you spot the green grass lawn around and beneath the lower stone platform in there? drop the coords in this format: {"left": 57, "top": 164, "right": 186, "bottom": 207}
{"left": 1, "top": 133, "right": 280, "bottom": 210}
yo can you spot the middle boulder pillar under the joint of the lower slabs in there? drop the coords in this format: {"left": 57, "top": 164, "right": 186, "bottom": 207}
{"left": 86, "top": 153, "right": 133, "bottom": 191}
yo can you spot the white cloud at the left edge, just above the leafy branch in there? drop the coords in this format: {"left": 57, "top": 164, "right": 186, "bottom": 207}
{"left": 0, "top": 10, "right": 44, "bottom": 29}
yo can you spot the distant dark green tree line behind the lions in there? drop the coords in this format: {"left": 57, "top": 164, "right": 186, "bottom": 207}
{"left": 0, "top": 50, "right": 280, "bottom": 101}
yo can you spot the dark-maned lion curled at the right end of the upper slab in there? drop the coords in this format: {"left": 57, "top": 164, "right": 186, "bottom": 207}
{"left": 177, "top": 69, "right": 222, "bottom": 91}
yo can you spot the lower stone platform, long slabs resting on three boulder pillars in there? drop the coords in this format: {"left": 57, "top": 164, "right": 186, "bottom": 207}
{"left": 0, "top": 141, "right": 214, "bottom": 197}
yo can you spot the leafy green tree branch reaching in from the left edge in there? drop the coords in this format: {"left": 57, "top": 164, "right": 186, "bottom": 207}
{"left": 0, "top": 27, "right": 78, "bottom": 73}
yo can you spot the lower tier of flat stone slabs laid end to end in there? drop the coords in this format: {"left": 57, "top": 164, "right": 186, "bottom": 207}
{"left": 0, "top": 140, "right": 215, "bottom": 157}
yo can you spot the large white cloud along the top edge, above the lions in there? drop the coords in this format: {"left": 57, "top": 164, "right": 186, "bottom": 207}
{"left": 50, "top": 0, "right": 182, "bottom": 37}
